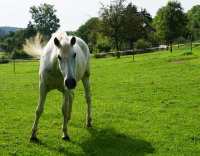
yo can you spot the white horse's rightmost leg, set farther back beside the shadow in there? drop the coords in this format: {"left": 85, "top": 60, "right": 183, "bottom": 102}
{"left": 82, "top": 75, "right": 92, "bottom": 127}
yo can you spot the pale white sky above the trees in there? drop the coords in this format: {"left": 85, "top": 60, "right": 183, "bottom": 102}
{"left": 0, "top": 0, "right": 200, "bottom": 31}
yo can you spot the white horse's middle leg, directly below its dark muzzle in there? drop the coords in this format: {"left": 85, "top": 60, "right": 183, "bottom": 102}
{"left": 62, "top": 91, "right": 74, "bottom": 141}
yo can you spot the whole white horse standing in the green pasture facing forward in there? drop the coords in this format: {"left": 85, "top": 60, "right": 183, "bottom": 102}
{"left": 24, "top": 32, "right": 92, "bottom": 141}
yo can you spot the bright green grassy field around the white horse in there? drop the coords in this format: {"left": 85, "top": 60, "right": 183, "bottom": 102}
{"left": 0, "top": 48, "right": 200, "bottom": 156}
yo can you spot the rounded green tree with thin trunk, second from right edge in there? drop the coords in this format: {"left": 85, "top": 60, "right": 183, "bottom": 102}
{"left": 154, "top": 1, "right": 187, "bottom": 52}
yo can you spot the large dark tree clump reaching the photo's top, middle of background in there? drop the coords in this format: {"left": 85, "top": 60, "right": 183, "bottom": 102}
{"left": 100, "top": 0, "right": 152, "bottom": 50}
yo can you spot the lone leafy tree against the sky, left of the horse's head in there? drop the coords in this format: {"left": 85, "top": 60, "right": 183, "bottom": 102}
{"left": 30, "top": 3, "right": 60, "bottom": 38}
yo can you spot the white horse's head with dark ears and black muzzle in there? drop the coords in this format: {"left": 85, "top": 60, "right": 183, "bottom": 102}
{"left": 54, "top": 36, "right": 76, "bottom": 89}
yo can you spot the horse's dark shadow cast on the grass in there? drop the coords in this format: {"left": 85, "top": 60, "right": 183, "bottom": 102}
{"left": 36, "top": 129, "right": 155, "bottom": 156}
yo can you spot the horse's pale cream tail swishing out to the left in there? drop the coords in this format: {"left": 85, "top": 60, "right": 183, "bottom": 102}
{"left": 23, "top": 33, "right": 43, "bottom": 57}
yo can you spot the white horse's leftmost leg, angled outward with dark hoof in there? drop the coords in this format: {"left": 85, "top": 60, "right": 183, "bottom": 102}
{"left": 30, "top": 83, "right": 47, "bottom": 141}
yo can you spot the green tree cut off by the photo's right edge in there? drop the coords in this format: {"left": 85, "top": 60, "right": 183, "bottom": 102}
{"left": 187, "top": 5, "right": 200, "bottom": 40}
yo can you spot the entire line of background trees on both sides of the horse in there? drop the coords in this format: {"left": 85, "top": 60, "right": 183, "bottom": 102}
{"left": 0, "top": 0, "right": 200, "bottom": 56}
